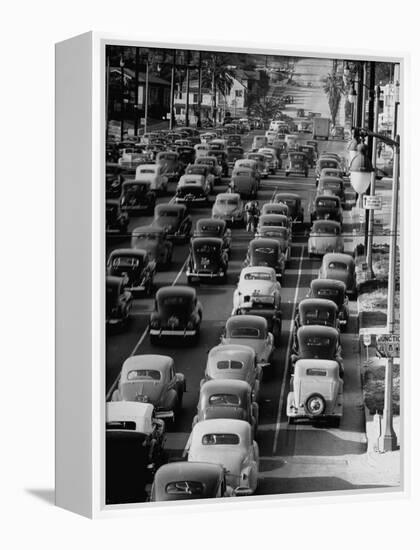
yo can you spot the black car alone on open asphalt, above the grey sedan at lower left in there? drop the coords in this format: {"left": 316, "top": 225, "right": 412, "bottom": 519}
{"left": 149, "top": 286, "right": 203, "bottom": 344}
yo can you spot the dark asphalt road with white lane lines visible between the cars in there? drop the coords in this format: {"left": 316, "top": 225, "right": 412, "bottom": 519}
{"left": 106, "top": 124, "right": 365, "bottom": 494}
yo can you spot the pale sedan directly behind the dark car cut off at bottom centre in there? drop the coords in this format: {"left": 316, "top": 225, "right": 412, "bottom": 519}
{"left": 188, "top": 418, "right": 259, "bottom": 496}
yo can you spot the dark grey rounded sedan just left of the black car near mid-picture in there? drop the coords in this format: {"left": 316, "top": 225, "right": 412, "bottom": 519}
{"left": 131, "top": 225, "right": 174, "bottom": 269}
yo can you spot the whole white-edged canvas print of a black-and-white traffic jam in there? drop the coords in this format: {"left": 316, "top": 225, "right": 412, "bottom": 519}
{"left": 56, "top": 33, "right": 407, "bottom": 517}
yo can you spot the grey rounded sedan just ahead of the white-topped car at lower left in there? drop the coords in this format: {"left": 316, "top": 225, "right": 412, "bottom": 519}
{"left": 111, "top": 355, "right": 186, "bottom": 420}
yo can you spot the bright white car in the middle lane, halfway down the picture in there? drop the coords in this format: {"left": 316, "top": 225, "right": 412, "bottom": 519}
{"left": 232, "top": 266, "right": 281, "bottom": 315}
